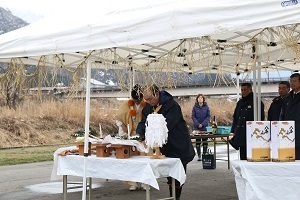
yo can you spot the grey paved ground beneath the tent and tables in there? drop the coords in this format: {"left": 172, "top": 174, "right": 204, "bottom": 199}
{"left": 0, "top": 146, "right": 238, "bottom": 200}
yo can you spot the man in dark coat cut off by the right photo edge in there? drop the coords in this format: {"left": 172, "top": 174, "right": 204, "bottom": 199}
{"left": 282, "top": 73, "right": 300, "bottom": 160}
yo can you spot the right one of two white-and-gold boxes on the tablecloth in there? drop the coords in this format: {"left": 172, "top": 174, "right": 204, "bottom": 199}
{"left": 271, "top": 121, "right": 295, "bottom": 162}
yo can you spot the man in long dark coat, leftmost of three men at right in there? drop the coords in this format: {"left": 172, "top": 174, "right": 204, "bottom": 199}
{"left": 229, "top": 83, "right": 265, "bottom": 160}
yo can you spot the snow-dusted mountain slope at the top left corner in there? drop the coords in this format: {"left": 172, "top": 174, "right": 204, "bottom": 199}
{"left": 0, "top": 7, "right": 28, "bottom": 35}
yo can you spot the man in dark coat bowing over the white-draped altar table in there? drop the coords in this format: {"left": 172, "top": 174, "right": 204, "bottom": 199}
{"left": 136, "top": 85, "right": 195, "bottom": 199}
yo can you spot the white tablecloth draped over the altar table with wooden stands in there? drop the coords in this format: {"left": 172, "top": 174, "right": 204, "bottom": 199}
{"left": 51, "top": 147, "right": 186, "bottom": 189}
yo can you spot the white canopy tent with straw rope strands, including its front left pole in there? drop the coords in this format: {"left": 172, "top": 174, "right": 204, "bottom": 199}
{"left": 0, "top": 0, "right": 300, "bottom": 199}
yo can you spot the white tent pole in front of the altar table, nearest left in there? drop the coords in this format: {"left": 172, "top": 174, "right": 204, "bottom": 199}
{"left": 82, "top": 58, "right": 91, "bottom": 200}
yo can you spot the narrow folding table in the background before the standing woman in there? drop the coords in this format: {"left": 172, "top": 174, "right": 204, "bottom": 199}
{"left": 190, "top": 132, "right": 230, "bottom": 169}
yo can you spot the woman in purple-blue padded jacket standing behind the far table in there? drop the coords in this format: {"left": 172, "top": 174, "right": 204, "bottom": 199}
{"left": 192, "top": 94, "right": 210, "bottom": 161}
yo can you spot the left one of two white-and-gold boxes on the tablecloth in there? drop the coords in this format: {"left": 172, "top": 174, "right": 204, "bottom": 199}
{"left": 246, "top": 121, "right": 271, "bottom": 162}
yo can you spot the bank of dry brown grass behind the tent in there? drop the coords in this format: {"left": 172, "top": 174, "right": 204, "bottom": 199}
{"left": 0, "top": 97, "right": 253, "bottom": 148}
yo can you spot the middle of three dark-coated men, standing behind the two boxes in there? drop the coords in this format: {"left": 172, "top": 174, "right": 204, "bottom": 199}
{"left": 268, "top": 81, "right": 290, "bottom": 121}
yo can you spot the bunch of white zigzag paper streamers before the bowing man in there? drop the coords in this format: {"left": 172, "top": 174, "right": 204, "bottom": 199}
{"left": 145, "top": 114, "right": 168, "bottom": 148}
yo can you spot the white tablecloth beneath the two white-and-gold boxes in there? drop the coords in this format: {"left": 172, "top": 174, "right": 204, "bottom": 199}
{"left": 231, "top": 161, "right": 300, "bottom": 200}
